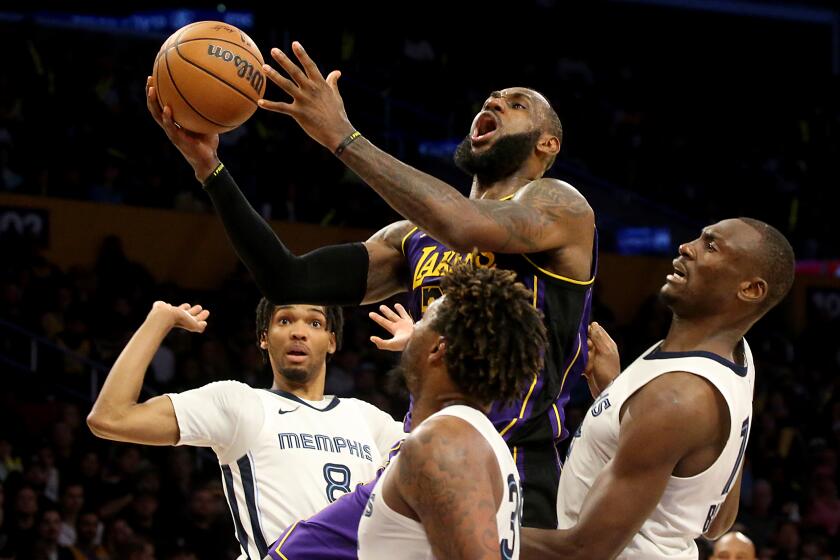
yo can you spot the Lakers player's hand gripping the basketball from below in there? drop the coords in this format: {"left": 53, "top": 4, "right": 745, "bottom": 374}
{"left": 146, "top": 76, "right": 219, "bottom": 182}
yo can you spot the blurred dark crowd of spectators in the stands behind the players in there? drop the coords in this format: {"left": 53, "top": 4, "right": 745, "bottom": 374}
{"left": 0, "top": 0, "right": 840, "bottom": 560}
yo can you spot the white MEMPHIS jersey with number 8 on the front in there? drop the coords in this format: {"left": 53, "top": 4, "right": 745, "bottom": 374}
{"left": 168, "top": 381, "right": 405, "bottom": 560}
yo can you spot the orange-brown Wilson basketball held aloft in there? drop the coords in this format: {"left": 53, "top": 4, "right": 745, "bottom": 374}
{"left": 152, "top": 21, "right": 265, "bottom": 133}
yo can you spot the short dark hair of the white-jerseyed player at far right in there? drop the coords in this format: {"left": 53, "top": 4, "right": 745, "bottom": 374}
{"left": 738, "top": 218, "right": 796, "bottom": 311}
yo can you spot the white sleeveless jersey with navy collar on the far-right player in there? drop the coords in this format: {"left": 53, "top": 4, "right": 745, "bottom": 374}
{"left": 557, "top": 340, "right": 755, "bottom": 559}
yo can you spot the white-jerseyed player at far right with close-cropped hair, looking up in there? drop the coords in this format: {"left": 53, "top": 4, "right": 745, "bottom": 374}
{"left": 522, "top": 218, "right": 794, "bottom": 560}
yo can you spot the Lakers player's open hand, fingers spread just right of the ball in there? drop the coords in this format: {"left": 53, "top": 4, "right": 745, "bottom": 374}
{"left": 258, "top": 41, "right": 354, "bottom": 151}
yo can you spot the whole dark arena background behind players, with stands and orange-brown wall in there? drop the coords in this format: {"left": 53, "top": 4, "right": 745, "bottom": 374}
{"left": 0, "top": 0, "right": 840, "bottom": 559}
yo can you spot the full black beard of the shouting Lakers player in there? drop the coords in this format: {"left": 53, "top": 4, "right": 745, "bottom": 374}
{"left": 453, "top": 130, "right": 542, "bottom": 183}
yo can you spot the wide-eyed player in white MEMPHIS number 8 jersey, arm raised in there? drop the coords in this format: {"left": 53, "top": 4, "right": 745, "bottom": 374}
{"left": 88, "top": 299, "right": 405, "bottom": 559}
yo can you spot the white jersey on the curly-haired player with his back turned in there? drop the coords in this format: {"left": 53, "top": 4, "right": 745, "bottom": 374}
{"left": 359, "top": 405, "right": 522, "bottom": 560}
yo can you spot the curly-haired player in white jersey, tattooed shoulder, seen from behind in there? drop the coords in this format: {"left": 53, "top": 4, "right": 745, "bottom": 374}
{"left": 354, "top": 265, "right": 547, "bottom": 560}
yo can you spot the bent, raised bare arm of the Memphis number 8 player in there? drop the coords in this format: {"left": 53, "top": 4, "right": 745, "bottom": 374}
{"left": 87, "top": 301, "right": 210, "bottom": 445}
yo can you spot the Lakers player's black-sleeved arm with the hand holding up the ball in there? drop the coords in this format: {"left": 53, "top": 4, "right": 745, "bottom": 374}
{"left": 146, "top": 77, "right": 410, "bottom": 305}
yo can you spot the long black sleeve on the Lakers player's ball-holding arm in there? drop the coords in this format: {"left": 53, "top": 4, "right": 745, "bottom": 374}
{"left": 204, "top": 169, "right": 369, "bottom": 305}
